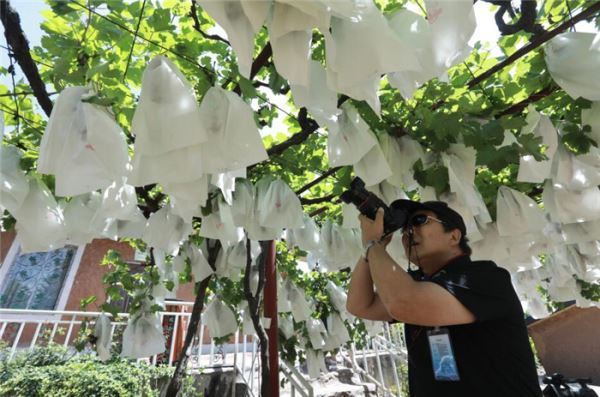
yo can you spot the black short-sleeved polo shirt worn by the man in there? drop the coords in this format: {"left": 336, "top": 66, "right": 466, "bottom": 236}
{"left": 405, "top": 255, "right": 542, "bottom": 397}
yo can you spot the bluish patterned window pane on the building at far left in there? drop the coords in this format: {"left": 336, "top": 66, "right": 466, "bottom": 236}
{"left": 0, "top": 246, "right": 78, "bottom": 310}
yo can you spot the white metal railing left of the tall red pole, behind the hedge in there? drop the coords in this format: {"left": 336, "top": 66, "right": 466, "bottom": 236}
{"left": 0, "top": 301, "right": 260, "bottom": 396}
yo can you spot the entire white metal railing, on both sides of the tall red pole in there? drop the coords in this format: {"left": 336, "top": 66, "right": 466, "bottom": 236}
{"left": 0, "top": 302, "right": 406, "bottom": 397}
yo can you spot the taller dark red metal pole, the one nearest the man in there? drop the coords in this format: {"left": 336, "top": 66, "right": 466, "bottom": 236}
{"left": 263, "top": 241, "right": 279, "bottom": 397}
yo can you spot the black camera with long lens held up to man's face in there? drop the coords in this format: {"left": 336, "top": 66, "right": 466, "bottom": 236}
{"left": 340, "top": 177, "right": 408, "bottom": 236}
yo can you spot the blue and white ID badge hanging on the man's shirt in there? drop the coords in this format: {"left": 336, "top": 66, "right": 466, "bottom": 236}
{"left": 427, "top": 328, "right": 460, "bottom": 381}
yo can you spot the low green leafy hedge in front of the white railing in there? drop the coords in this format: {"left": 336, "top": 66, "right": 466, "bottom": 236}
{"left": 0, "top": 345, "right": 197, "bottom": 397}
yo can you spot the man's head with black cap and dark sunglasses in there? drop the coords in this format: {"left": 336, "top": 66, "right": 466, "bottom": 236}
{"left": 392, "top": 200, "right": 471, "bottom": 266}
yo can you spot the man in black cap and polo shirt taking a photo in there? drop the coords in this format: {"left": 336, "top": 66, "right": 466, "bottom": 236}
{"left": 347, "top": 200, "right": 542, "bottom": 397}
